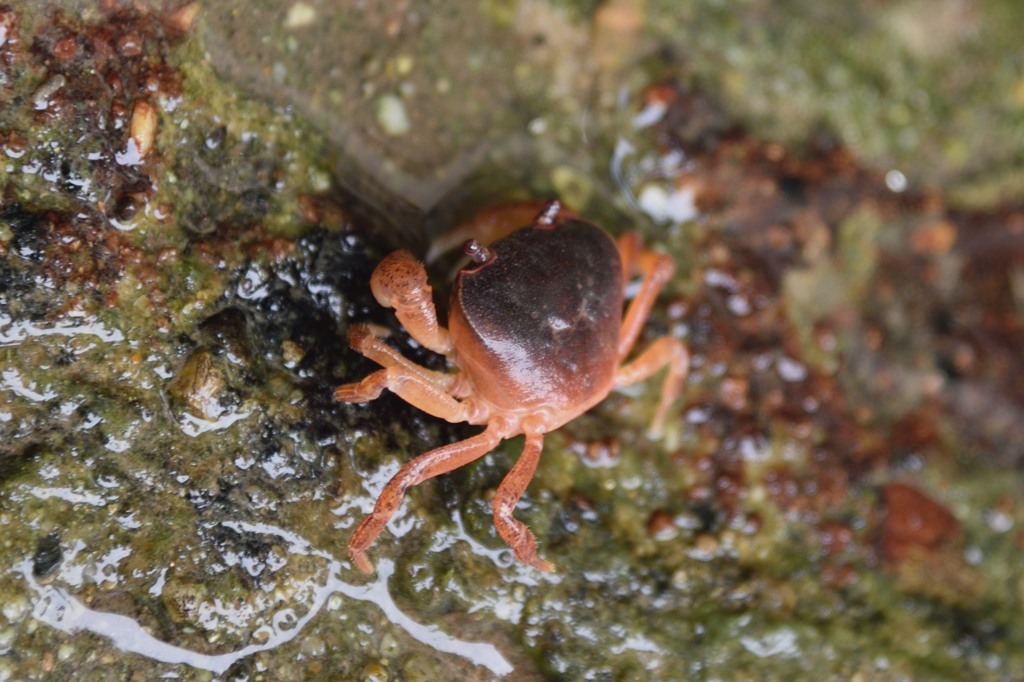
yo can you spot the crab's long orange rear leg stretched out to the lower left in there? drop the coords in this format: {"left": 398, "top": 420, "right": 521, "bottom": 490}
{"left": 348, "top": 421, "right": 502, "bottom": 573}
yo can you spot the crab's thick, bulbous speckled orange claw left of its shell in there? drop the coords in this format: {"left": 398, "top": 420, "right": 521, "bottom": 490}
{"left": 370, "top": 251, "right": 452, "bottom": 354}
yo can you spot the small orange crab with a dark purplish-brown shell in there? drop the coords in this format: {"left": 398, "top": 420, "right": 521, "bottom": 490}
{"left": 335, "top": 201, "right": 689, "bottom": 572}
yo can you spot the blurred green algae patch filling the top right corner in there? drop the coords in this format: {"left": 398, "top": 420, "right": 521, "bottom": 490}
{"left": 647, "top": 0, "right": 1024, "bottom": 208}
